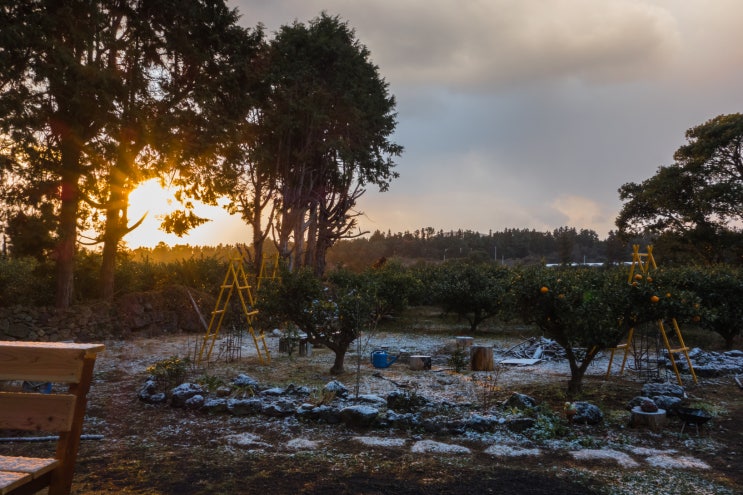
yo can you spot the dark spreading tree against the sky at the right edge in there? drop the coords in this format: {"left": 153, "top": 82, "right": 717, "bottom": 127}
{"left": 616, "top": 114, "right": 743, "bottom": 262}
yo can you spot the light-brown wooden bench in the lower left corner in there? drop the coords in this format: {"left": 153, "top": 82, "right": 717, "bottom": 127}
{"left": 0, "top": 341, "right": 104, "bottom": 495}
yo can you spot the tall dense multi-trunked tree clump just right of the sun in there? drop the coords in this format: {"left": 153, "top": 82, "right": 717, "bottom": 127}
{"left": 247, "top": 13, "right": 402, "bottom": 274}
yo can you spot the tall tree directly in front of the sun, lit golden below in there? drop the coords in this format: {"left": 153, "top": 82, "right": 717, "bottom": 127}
{"left": 87, "top": 0, "right": 262, "bottom": 298}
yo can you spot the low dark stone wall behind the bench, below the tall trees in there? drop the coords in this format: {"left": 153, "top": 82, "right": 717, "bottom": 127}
{"left": 0, "top": 286, "right": 216, "bottom": 342}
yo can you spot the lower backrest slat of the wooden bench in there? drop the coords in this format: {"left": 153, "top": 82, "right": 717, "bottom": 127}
{"left": 0, "top": 392, "right": 76, "bottom": 432}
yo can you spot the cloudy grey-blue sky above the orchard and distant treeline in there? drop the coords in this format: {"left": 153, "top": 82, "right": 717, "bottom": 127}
{"left": 127, "top": 0, "right": 743, "bottom": 247}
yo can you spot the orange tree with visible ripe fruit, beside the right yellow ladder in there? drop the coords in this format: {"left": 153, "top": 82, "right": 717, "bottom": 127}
{"left": 510, "top": 267, "right": 634, "bottom": 396}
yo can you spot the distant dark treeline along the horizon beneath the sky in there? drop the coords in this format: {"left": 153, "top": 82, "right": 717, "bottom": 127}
{"left": 131, "top": 227, "right": 657, "bottom": 270}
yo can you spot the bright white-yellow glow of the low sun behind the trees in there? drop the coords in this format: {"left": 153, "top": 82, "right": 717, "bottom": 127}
{"left": 124, "top": 179, "right": 249, "bottom": 249}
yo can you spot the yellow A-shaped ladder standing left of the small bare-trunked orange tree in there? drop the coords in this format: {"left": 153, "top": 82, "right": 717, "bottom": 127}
{"left": 197, "top": 256, "right": 271, "bottom": 364}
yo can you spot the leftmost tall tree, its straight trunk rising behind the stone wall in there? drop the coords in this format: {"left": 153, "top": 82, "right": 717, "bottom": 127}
{"left": 0, "top": 0, "right": 116, "bottom": 307}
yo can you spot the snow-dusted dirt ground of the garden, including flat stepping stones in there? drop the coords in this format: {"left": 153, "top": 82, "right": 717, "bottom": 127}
{"left": 0, "top": 326, "right": 743, "bottom": 495}
